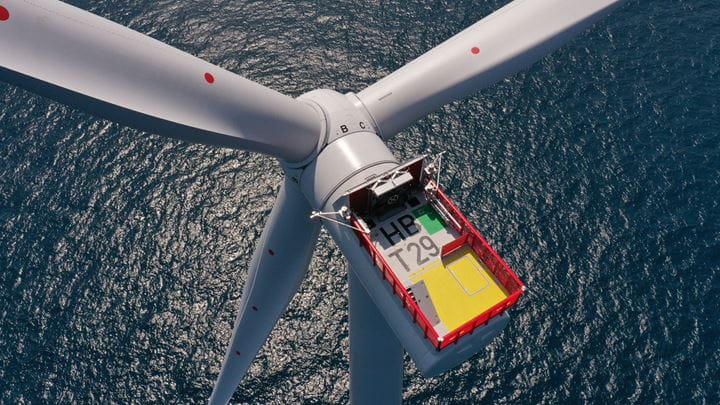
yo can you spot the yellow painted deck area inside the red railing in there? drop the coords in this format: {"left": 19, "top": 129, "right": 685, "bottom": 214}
{"left": 410, "top": 246, "right": 508, "bottom": 330}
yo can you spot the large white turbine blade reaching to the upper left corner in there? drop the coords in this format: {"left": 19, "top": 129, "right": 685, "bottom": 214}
{"left": 0, "top": 0, "right": 321, "bottom": 162}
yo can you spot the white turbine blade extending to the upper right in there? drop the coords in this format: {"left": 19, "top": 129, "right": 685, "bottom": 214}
{"left": 357, "top": 0, "right": 623, "bottom": 138}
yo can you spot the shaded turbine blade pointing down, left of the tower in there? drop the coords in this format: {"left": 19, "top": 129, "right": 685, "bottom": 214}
{"left": 210, "top": 179, "right": 320, "bottom": 404}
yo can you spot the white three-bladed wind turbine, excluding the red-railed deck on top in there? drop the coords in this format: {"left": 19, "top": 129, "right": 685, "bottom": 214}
{"left": 0, "top": 0, "right": 622, "bottom": 404}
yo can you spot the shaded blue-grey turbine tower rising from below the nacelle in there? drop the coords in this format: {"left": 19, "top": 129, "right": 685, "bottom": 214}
{"left": 348, "top": 264, "right": 404, "bottom": 405}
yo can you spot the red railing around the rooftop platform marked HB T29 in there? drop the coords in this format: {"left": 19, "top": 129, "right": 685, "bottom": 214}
{"left": 352, "top": 180, "right": 525, "bottom": 350}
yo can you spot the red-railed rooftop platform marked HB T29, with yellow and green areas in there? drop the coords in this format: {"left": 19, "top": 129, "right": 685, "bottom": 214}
{"left": 348, "top": 158, "right": 525, "bottom": 350}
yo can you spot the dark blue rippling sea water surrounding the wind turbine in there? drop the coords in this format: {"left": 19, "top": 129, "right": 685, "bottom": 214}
{"left": 0, "top": 0, "right": 720, "bottom": 404}
